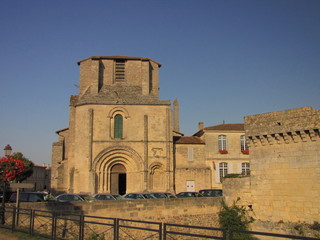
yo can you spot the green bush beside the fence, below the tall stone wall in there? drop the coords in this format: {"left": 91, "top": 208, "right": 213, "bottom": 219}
{"left": 219, "top": 198, "right": 255, "bottom": 240}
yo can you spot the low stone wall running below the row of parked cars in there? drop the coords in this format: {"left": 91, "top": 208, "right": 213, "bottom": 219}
{"left": 11, "top": 197, "right": 222, "bottom": 227}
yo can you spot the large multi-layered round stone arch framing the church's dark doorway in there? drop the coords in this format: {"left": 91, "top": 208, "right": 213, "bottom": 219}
{"left": 93, "top": 146, "right": 143, "bottom": 192}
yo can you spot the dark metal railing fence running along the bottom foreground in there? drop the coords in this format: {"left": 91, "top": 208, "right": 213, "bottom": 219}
{"left": 0, "top": 207, "right": 319, "bottom": 240}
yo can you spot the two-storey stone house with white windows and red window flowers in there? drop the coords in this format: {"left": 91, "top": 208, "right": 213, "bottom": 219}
{"left": 194, "top": 122, "right": 250, "bottom": 188}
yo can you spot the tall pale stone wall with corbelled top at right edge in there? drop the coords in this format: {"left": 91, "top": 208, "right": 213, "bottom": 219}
{"left": 245, "top": 107, "right": 320, "bottom": 223}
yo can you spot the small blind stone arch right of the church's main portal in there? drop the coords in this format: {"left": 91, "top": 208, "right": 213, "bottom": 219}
{"left": 149, "top": 162, "right": 166, "bottom": 192}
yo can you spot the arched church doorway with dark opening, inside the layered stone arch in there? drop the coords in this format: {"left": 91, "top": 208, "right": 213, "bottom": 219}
{"left": 110, "top": 164, "right": 127, "bottom": 195}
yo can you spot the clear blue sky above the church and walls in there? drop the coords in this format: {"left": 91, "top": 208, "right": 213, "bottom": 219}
{"left": 0, "top": 0, "right": 320, "bottom": 164}
